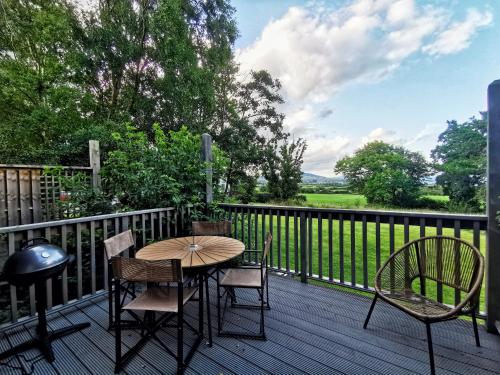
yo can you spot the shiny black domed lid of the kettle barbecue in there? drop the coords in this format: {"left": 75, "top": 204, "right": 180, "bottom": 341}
{"left": 3, "top": 238, "right": 69, "bottom": 278}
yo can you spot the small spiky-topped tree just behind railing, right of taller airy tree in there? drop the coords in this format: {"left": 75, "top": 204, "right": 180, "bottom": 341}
{"left": 262, "top": 138, "right": 307, "bottom": 200}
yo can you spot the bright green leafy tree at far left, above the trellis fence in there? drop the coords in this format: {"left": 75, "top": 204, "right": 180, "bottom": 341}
{"left": 0, "top": 0, "right": 92, "bottom": 163}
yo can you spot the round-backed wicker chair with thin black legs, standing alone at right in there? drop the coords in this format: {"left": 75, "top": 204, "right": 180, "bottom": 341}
{"left": 363, "top": 236, "right": 484, "bottom": 374}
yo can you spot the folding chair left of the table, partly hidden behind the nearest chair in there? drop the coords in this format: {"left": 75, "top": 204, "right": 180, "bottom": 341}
{"left": 104, "top": 229, "right": 137, "bottom": 329}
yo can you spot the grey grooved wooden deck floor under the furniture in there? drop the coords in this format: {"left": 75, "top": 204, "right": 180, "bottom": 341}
{"left": 0, "top": 276, "right": 500, "bottom": 375}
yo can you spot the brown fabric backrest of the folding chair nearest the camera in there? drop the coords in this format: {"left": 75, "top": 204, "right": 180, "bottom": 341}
{"left": 111, "top": 256, "right": 182, "bottom": 283}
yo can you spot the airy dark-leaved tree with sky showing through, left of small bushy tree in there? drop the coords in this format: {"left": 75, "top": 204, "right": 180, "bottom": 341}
{"left": 211, "top": 66, "right": 288, "bottom": 195}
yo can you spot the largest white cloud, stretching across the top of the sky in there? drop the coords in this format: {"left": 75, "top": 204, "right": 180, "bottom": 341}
{"left": 237, "top": 0, "right": 492, "bottom": 103}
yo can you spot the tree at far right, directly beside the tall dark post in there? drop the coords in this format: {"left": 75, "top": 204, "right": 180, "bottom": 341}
{"left": 431, "top": 112, "right": 487, "bottom": 211}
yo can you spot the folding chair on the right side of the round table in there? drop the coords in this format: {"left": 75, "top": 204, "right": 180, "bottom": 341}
{"left": 217, "top": 233, "right": 272, "bottom": 340}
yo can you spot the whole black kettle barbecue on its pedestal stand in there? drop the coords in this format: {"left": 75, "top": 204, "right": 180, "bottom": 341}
{"left": 0, "top": 237, "right": 90, "bottom": 362}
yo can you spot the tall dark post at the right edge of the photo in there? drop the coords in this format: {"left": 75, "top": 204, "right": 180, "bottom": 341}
{"left": 486, "top": 80, "right": 500, "bottom": 332}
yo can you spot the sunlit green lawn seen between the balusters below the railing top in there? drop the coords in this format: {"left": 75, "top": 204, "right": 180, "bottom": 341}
{"left": 233, "top": 213, "right": 485, "bottom": 311}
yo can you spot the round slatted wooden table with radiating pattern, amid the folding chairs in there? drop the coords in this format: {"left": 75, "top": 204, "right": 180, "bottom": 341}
{"left": 135, "top": 236, "right": 245, "bottom": 346}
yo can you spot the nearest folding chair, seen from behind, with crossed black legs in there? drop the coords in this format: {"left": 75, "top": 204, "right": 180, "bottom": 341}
{"left": 112, "top": 257, "right": 203, "bottom": 374}
